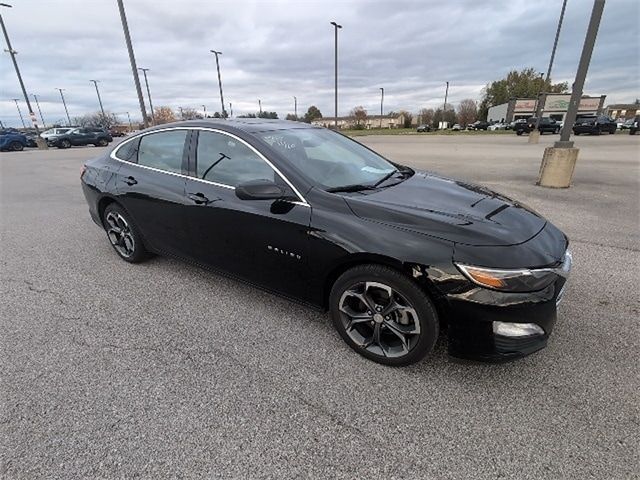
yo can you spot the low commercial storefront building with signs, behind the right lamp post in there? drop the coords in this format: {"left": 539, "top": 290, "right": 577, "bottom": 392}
{"left": 487, "top": 93, "right": 606, "bottom": 123}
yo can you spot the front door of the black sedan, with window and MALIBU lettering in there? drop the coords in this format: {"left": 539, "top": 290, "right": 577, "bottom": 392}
{"left": 185, "top": 130, "right": 311, "bottom": 298}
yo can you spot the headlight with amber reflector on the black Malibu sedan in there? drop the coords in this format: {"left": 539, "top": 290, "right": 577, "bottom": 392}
{"left": 455, "top": 250, "right": 572, "bottom": 292}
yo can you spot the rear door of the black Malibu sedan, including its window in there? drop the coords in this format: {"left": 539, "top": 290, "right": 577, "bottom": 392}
{"left": 115, "top": 129, "right": 191, "bottom": 256}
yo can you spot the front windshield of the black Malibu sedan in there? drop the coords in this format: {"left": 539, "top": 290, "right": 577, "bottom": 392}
{"left": 256, "top": 128, "right": 397, "bottom": 189}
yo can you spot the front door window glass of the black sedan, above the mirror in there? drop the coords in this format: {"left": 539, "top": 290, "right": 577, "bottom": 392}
{"left": 196, "top": 131, "right": 275, "bottom": 187}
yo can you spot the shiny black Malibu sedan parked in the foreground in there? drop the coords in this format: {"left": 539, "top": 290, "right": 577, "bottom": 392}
{"left": 81, "top": 119, "right": 571, "bottom": 365}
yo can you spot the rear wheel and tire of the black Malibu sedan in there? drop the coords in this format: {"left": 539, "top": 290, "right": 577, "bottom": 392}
{"left": 102, "top": 203, "right": 150, "bottom": 263}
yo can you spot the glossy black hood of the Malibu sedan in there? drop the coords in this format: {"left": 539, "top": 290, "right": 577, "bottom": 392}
{"left": 345, "top": 172, "right": 546, "bottom": 246}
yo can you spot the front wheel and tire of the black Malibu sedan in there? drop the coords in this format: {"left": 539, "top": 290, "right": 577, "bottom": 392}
{"left": 329, "top": 264, "right": 439, "bottom": 367}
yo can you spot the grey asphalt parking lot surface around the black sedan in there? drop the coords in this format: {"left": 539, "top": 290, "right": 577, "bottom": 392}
{"left": 0, "top": 135, "right": 640, "bottom": 480}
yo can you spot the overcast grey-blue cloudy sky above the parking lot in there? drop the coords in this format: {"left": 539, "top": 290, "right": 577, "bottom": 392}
{"left": 0, "top": 0, "right": 640, "bottom": 126}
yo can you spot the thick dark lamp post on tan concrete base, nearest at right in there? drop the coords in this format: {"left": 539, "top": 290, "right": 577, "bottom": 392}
{"left": 536, "top": 0, "right": 605, "bottom": 188}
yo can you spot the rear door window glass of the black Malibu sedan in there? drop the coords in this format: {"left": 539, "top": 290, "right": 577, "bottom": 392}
{"left": 138, "top": 130, "right": 188, "bottom": 173}
